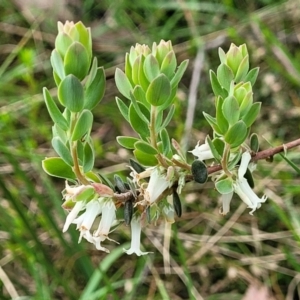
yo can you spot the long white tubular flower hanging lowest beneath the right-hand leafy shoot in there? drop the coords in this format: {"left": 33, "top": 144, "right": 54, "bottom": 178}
{"left": 234, "top": 152, "right": 267, "bottom": 215}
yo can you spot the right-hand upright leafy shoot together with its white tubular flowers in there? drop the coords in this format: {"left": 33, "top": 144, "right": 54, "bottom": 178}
{"left": 192, "top": 44, "right": 266, "bottom": 214}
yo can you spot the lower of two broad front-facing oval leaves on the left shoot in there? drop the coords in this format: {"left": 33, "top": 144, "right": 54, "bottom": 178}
{"left": 58, "top": 75, "right": 84, "bottom": 112}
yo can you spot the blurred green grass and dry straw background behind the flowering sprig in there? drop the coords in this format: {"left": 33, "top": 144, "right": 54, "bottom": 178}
{"left": 0, "top": 0, "right": 300, "bottom": 300}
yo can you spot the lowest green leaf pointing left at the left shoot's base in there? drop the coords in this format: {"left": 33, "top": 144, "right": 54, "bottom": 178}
{"left": 42, "top": 157, "right": 76, "bottom": 181}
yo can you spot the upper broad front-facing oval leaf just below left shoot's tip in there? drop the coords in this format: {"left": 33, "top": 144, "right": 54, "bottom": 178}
{"left": 64, "top": 42, "right": 91, "bottom": 80}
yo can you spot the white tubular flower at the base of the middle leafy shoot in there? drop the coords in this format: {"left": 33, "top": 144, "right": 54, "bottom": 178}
{"left": 144, "top": 168, "right": 170, "bottom": 205}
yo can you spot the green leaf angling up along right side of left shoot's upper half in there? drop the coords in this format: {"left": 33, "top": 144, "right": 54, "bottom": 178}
{"left": 84, "top": 67, "right": 105, "bottom": 110}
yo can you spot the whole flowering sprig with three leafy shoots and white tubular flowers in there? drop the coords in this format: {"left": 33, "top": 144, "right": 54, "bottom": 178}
{"left": 43, "top": 22, "right": 300, "bottom": 255}
